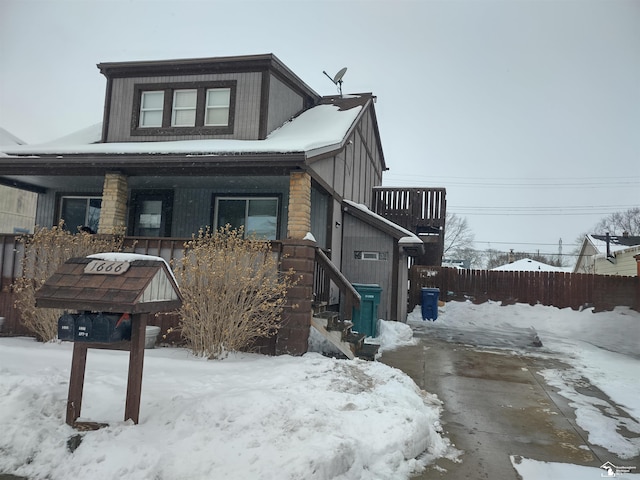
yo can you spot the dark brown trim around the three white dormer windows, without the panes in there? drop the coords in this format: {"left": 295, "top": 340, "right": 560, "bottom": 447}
{"left": 131, "top": 80, "right": 238, "bottom": 136}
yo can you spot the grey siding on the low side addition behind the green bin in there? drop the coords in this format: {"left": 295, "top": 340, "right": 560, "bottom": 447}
{"left": 342, "top": 215, "right": 396, "bottom": 320}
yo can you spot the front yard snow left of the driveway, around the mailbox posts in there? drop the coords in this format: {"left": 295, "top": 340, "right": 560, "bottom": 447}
{"left": 0, "top": 322, "right": 452, "bottom": 480}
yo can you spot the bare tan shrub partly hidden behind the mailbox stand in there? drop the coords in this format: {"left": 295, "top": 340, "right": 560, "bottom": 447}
{"left": 12, "top": 222, "right": 124, "bottom": 342}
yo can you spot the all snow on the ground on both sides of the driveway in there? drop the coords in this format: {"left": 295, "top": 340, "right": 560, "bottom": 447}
{"left": 0, "top": 302, "right": 640, "bottom": 480}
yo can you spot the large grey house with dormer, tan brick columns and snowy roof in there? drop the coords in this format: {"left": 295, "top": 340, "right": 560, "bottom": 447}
{"left": 0, "top": 54, "right": 444, "bottom": 353}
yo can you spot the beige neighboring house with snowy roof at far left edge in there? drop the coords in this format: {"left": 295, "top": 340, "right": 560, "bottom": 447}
{"left": 0, "top": 128, "right": 38, "bottom": 233}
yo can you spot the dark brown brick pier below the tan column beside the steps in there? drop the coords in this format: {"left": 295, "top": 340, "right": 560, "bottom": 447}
{"left": 275, "top": 240, "right": 316, "bottom": 355}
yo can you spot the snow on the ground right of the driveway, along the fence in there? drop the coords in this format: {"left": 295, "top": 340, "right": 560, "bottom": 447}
{"left": 408, "top": 301, "right": 640, "bottom": 480}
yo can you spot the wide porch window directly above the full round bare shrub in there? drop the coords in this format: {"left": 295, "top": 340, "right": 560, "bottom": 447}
{"left": 214, "top": 197, "right": 278, "bottom": 240}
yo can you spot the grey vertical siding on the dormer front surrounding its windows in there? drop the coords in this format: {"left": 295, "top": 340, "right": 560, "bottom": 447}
{"left": 106, "top": 72, "right": 262, "bottom": 142}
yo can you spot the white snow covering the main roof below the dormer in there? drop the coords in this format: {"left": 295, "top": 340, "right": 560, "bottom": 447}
{"left": 0, "top": 105, "right": 363, "bottom": 156}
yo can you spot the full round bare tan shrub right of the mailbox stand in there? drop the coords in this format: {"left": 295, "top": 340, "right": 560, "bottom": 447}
{"left": 175, "top": 225, "right": 295, "bottom": 359}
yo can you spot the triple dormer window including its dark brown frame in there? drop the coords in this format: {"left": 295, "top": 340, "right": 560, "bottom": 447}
{"left": 131, "top": 81, "right": 236, "bottom": 135}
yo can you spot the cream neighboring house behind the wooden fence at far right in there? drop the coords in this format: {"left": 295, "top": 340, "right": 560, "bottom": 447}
{"left": 573, "top": 234, "right": 640, "bottom": 277}
